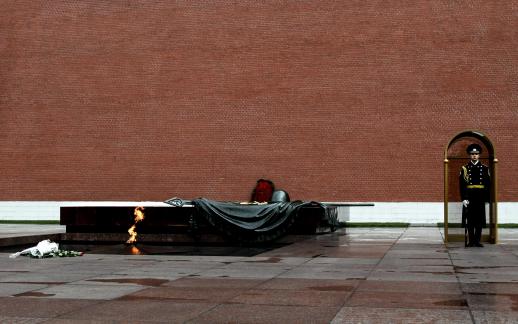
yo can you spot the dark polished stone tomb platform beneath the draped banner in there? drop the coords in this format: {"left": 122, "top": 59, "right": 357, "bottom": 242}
{"left": 60, "top": 204, "right": 339, "bottom": 243}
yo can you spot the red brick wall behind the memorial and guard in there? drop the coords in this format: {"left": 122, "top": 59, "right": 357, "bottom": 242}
{"left": 0, "top": 0, "right": 518, "bottom": 201}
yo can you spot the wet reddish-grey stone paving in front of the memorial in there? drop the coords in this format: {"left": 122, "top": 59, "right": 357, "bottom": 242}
{"left": 0, "top": 225, "right": 518, "bottom": 323}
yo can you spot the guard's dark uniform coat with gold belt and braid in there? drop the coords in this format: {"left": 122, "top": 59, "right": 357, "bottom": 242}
{"left": 459, "top": 161, "right": 491, "bottom": 227}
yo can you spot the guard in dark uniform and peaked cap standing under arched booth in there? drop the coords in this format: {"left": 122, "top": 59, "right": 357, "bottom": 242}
{"left": 459, "top": 144, "right": 491, "bottom": 247}
